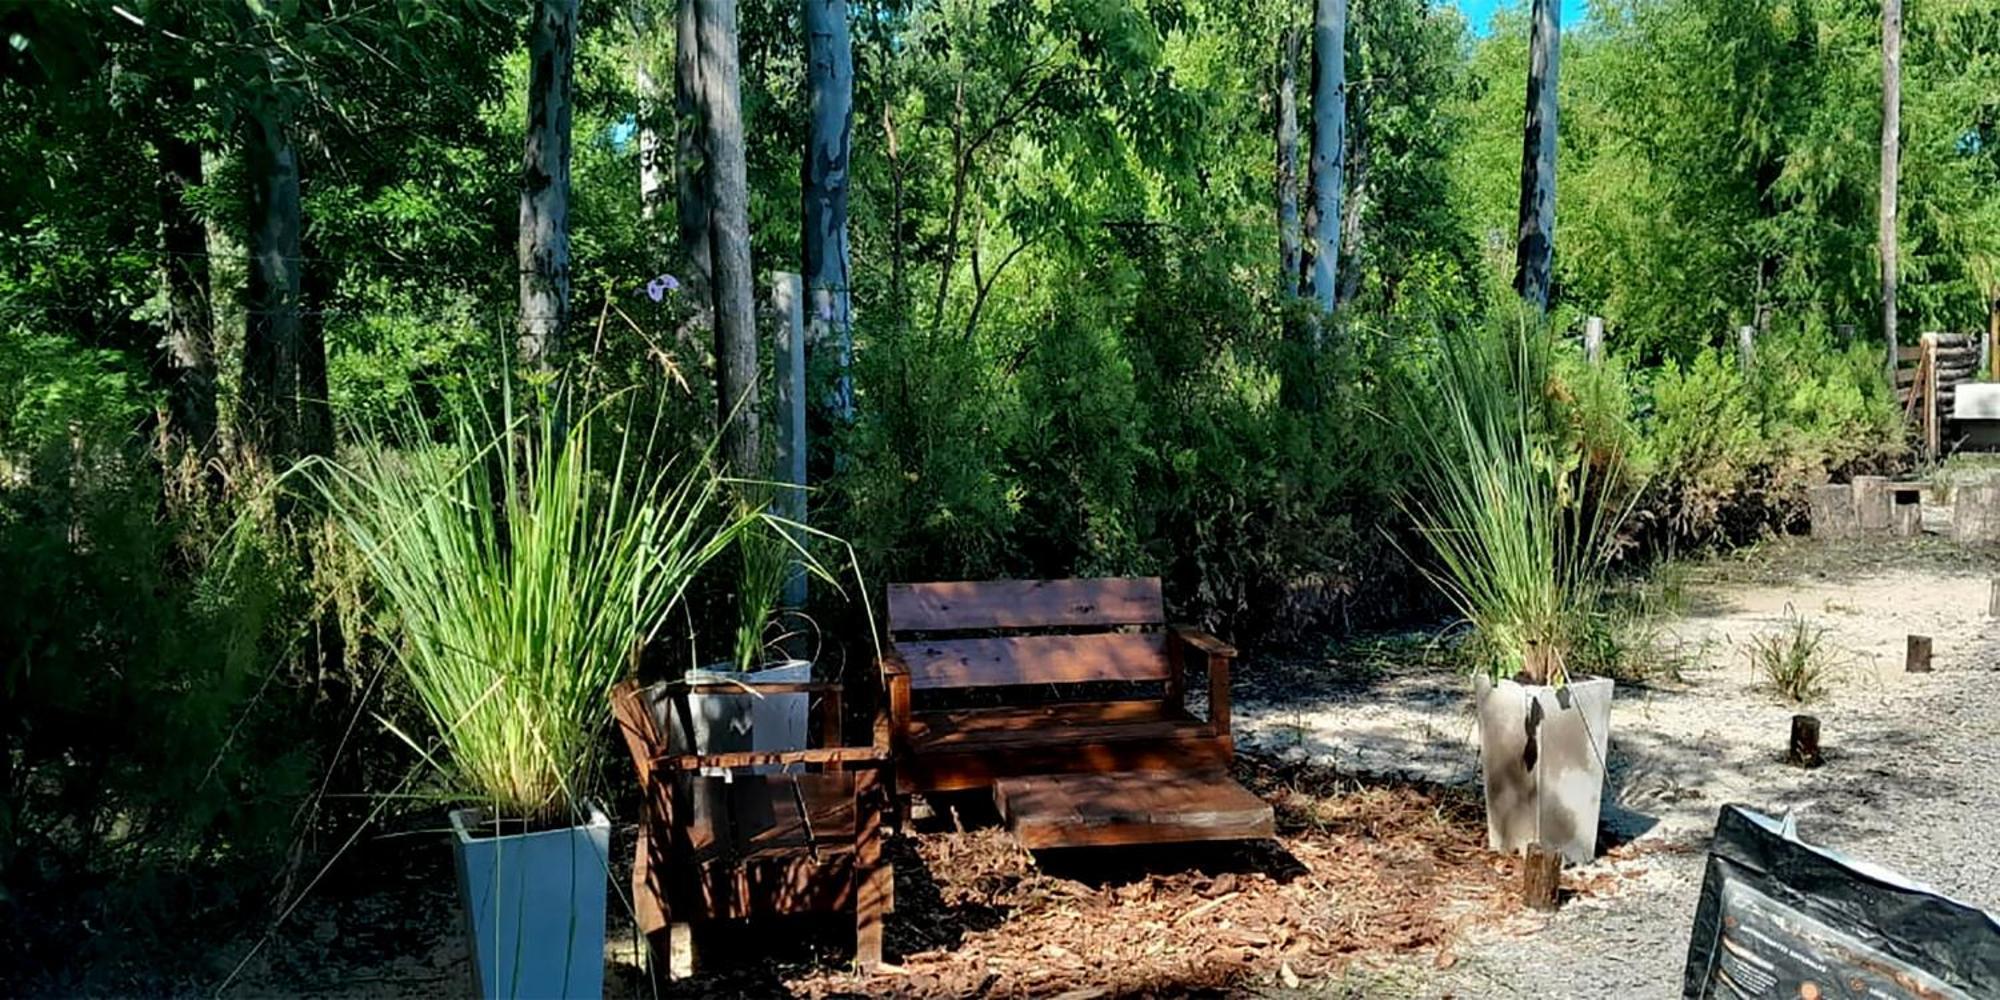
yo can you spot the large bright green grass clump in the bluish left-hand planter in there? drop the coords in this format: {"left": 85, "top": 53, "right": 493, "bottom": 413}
{"left": 304, "top": 396, "right": 762, "bottom": 828}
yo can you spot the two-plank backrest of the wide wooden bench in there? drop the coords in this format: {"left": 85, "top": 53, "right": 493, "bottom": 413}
{"left": 888, "top": 576, "right": 1168, "bottom": 690}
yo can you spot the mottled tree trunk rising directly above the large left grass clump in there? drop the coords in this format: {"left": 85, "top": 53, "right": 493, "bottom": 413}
{"left": 516, "top": 0, "right": 576, "bottom": 368}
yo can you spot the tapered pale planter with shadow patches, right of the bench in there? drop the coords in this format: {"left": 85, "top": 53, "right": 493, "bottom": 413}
{"left": 1474, "top": 676, "right": 1612, "bottom": 864}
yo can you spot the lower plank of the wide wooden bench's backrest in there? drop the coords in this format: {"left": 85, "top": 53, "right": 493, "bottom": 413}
{"left": 896, "top": 632, "right": 1168, "bottom": 690}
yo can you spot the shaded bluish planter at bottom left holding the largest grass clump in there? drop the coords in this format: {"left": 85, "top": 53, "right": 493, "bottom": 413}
{"left": 452, "top": 804, "right": 612, "bottom": 1000}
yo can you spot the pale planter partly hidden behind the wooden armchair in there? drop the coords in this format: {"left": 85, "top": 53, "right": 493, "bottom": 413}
{"left": 654, "top": 660, "right": 812, "bottom": 774}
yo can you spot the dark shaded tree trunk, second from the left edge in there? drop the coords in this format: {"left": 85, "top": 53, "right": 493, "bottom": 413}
{"left": 242, "top": 110, "right": 302, "bottom": 460}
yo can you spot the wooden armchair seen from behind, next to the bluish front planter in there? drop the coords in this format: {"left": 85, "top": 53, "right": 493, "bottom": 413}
{"left": 612, "top": 680, "right": 896, "bottom": 978}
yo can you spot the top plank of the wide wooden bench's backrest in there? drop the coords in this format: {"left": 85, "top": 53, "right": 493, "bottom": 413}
{"left": 888, "top": 576, "right": 1166, "bottom": 632}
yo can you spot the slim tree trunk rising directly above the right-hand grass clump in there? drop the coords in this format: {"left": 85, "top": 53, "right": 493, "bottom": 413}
{"left": 1514, "top": 0, "right": 1562, "bottom": 312}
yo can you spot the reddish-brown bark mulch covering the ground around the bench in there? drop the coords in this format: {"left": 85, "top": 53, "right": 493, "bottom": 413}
{"left": 638, "top": 758, "right": 1518, "bottom": 1000}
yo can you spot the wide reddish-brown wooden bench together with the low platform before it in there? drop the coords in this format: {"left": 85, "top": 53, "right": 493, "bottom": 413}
{"left": 882, "top": 578, "right": 1272, "bottom": 848}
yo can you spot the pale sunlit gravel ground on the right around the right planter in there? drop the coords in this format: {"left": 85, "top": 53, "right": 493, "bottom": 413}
{"left": 1238, "top": 554, "right": 2000, "bottom": 998}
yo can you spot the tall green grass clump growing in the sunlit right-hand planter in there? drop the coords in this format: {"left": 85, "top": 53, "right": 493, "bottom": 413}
{"left": 1404, "top": 320, "right": 1630, "bottom": 686}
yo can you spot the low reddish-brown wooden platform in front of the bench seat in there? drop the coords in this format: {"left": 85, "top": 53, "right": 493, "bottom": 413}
{"left": 994, "top": 770, "right": 1274, "bottom": 850}
